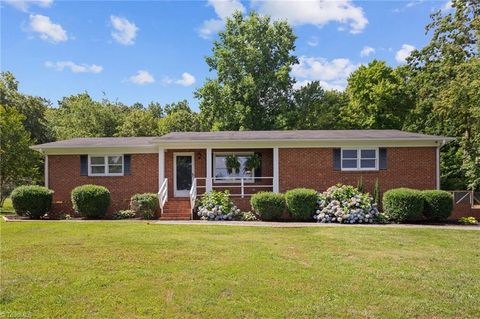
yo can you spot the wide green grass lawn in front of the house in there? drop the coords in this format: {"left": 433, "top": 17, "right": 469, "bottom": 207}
{"left": 0, "top": 222, "right": 480, "bottom": 318}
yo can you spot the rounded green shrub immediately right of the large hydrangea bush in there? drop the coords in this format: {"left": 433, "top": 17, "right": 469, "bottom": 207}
{"left": 383, "top": 188, "right": 424, "bottom": 223}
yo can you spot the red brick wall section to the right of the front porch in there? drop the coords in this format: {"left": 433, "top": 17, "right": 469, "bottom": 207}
{"left": 279, "top": 147, "right": 436, "bottom": 192}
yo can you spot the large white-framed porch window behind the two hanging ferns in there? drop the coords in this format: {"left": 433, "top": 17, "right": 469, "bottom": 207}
{"left": 213, "top": 152, "right": 255, "bottom": 182}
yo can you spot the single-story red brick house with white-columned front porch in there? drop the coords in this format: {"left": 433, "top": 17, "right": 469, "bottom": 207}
{"left": 33, "top": 130, "right": 452, "bottom": 219}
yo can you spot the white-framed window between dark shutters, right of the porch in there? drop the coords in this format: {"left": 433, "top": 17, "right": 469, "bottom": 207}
{"left": 341, "top": 148, "right": 378, "bottom": 171}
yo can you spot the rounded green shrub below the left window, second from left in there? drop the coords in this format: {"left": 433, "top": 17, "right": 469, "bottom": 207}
{"left": 72, "top": 185, "right": 110, "bottom": 218}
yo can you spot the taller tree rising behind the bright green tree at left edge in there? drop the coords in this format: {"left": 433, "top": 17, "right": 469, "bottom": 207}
{"left": 0, "top": 72, "right": 54, "bottom": 143}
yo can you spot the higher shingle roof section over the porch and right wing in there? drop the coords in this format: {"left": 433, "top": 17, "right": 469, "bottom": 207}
{"left": 155, "top": 130, "right": 450, "bottom": 142}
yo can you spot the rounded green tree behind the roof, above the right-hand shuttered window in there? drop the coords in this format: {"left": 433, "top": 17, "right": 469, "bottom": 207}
{"left": 342, "top": 60, "right": 413, "bottom": 129}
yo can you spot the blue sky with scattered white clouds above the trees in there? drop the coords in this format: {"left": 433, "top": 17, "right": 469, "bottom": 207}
{"left": 0, "top": 0, "right": 448, "bottom": 109}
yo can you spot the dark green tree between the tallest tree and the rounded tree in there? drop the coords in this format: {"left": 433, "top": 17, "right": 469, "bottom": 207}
{"left": 282, "top": 81, "right": 347, "bottom": 130}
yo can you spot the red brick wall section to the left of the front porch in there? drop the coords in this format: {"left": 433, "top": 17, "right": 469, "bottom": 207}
{"left": 48, "top": 154, "right": 158, "bottom": 218}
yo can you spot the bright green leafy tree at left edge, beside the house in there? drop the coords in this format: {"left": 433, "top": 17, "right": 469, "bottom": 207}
{"left": 0, "top": 104, "right": 40, "bottom": 207}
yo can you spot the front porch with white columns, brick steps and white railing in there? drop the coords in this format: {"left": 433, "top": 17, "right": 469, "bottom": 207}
{"left": 158, "top": 148, "right": 279, "bottom": 219}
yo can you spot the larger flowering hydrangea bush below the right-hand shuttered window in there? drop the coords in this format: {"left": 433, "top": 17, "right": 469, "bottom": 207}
{"left": 314, "top": 184, "right": 381, "bottom": 224}
